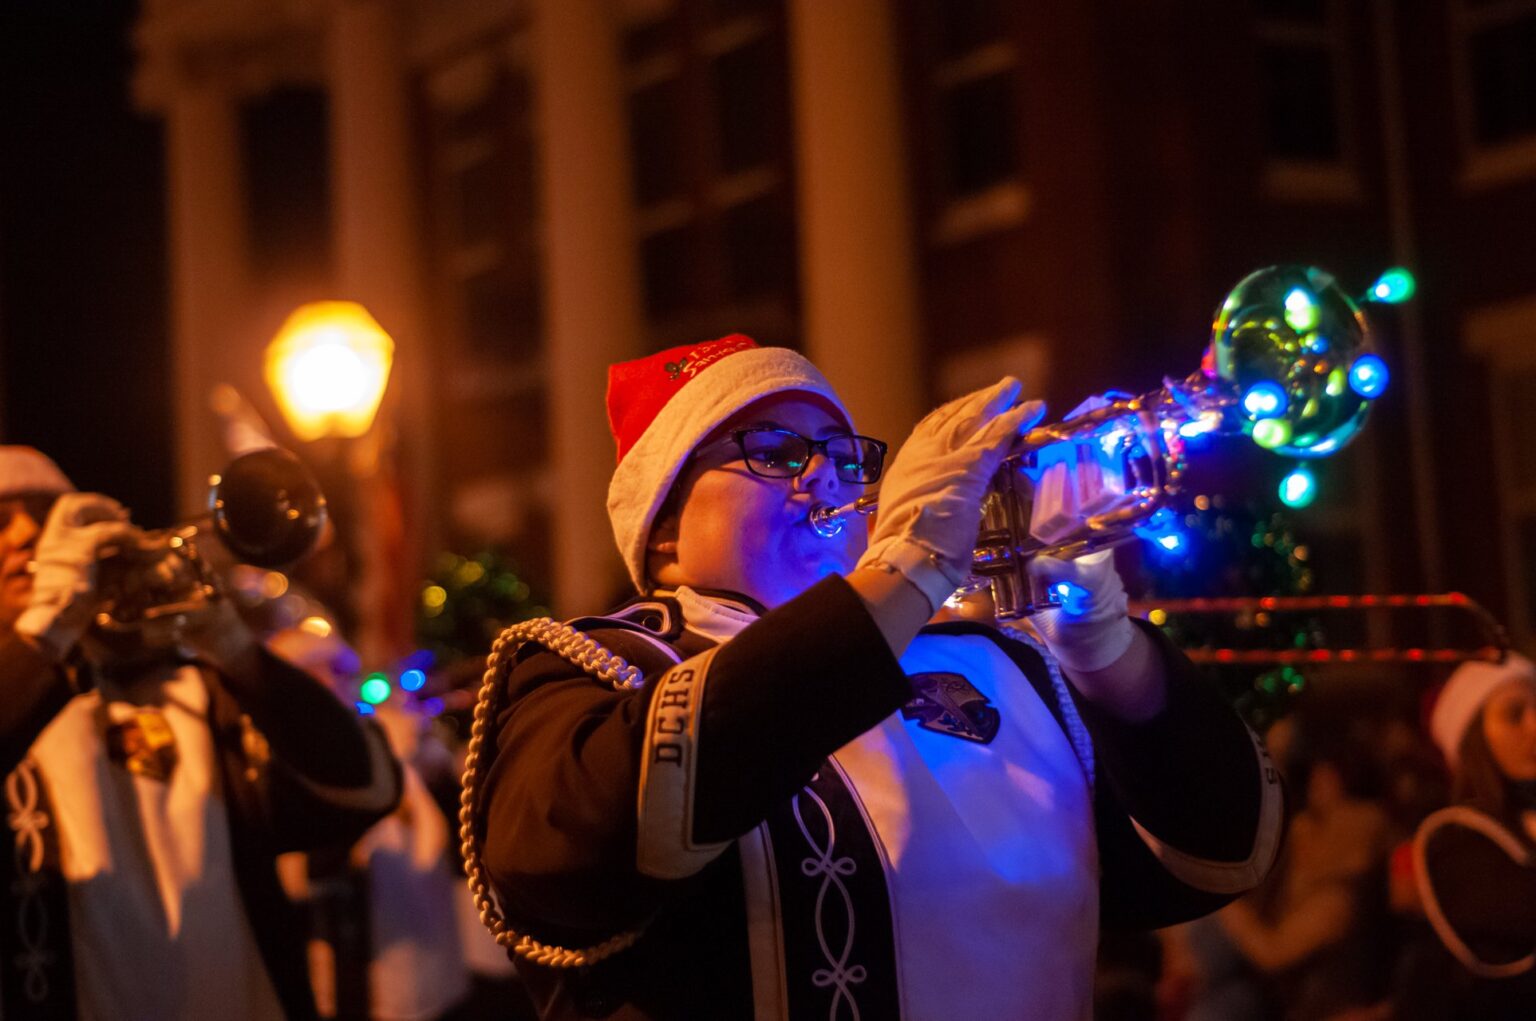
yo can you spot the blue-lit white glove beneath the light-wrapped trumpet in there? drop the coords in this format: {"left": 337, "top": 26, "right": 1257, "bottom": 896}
{"left": 1029, "top": 550, "right": 1137, "bottom": 672}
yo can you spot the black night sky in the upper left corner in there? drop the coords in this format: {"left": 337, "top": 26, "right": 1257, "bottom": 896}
{"left": 0, "top": 0, "right": 174, "bottom": 525}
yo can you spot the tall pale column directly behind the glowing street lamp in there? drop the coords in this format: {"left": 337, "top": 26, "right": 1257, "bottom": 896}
{"left": 327, "top": 0, "right": 436, "bottom": 663}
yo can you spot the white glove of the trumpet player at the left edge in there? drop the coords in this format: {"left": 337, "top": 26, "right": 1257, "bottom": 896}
{"left": 15, "top": 493, "right": 132, "bottom": 659}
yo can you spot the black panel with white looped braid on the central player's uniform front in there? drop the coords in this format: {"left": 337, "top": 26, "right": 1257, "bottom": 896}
{"left": 766, "top": 762, "right": 902, "bottom": 1021}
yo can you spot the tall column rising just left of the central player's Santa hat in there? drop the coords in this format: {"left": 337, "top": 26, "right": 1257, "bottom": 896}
{"left": 533, "top": 0, "right": 645, "bottom": 614}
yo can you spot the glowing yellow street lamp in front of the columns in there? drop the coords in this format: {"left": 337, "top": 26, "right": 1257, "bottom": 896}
{"left": 266, "top": 301, "right": 395, "bottom": 441}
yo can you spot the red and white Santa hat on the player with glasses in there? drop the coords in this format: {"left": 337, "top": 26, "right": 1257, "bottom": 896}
{"left": 608, "top": 333, "right": 852, "bottom": 593}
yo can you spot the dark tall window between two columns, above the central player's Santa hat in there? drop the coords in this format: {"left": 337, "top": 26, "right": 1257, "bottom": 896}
{"left": 625, "top": 0, "right": 799, "bottom": 330}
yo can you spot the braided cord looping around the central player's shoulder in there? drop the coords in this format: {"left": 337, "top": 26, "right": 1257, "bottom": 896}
{"left": 459, "top": 617, "right": 644, "bottom": 967}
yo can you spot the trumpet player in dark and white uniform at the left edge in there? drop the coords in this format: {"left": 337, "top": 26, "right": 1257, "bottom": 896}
{"left": 0, "top": 447, "right": 399, "bottom": 1021}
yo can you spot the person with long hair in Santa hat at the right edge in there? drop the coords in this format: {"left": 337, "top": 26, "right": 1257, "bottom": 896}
{"left": 1395, "top": 653, "right": 1536, "bottom": 1021}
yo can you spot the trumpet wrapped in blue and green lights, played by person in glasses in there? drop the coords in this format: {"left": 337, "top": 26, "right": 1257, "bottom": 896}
{"left": 809, "top": 266, "right": 1389, "bottom": 620}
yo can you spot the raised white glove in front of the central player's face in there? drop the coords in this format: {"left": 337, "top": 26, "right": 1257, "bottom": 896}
{"left": 859, "top": 376, "right": 1046, "bottom": 611}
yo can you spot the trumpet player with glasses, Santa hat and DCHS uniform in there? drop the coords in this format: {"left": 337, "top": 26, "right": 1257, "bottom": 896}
{"left": 465, "top": 336, "right": 1283, "bottom": 1021}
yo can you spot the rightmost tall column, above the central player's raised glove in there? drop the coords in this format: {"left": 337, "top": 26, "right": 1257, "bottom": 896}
{"left": 790, "top": 0, "right": 925, "bottom": 444}
